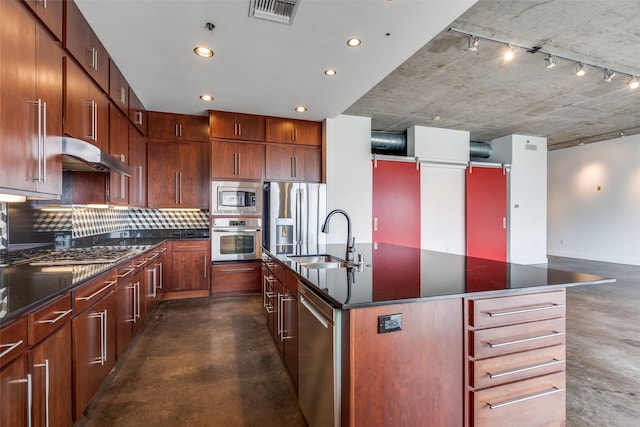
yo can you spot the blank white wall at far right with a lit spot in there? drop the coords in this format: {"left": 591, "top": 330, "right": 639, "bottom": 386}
{"left": 547, "top": 135, "right": 640, "bottom": 265}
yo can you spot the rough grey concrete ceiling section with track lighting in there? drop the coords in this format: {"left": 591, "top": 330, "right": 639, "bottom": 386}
{"left": 345, "top": 0, "right": 640, "bottom": 150}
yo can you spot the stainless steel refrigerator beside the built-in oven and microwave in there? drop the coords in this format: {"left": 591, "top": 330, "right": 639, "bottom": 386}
{"left": 262, "top": 182, "right": 327, "bottom": 254}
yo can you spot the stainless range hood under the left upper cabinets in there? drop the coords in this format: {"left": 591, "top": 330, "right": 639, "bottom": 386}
{"left": 62, "top": 137, "right": 131, "bottom": 176}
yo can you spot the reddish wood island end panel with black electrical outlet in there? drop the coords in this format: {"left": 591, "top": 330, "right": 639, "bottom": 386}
{"left": 342, "top": 298, "right": 464, "bottom": 426}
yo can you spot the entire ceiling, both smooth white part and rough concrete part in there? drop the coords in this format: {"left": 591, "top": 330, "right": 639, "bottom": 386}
{"left": 76, "top": 0, "right": 640, "bottom": 149}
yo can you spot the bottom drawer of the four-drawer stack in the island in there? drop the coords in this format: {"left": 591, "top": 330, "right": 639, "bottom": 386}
{"left": 471, "top": 372, "right": 565, "bottom": 427}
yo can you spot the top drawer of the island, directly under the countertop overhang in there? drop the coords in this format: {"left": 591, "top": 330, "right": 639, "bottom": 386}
{"left": 468, "top": 290, "right": 565, "bottom": 328}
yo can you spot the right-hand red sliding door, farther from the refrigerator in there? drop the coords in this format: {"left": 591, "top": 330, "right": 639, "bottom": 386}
{"left": 466, "top": 167, "right": 507, "bottom": 261}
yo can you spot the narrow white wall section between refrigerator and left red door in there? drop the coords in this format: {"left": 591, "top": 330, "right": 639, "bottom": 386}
{"left": 325, "top": 115, "right": 373, "bottom": 244}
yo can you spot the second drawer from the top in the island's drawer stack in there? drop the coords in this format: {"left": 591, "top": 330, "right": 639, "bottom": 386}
{"left": 469, "top": 318, "right": 566, "bottom": 359}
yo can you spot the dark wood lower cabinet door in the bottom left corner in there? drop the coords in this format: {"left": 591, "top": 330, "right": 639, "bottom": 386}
{"left": 0, "top": 356, "right": 31, "bottom": 427}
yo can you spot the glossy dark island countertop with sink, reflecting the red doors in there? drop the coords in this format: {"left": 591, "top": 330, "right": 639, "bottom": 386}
{"left": 266, "top": 243, "right": 615, "bottom": 309}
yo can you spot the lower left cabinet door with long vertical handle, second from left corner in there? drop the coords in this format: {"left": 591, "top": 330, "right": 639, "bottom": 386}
{"left": 29, "top": 322, "right": 73, "bottom": 427}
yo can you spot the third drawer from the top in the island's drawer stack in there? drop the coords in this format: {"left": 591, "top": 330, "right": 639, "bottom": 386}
{"left": 469, "top": 345, "right": 566, "bottom": 389}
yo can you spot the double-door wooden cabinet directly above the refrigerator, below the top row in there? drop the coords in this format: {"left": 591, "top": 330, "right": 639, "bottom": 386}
{"left": 265, "top": 145, "right": 322, "bottom": 182}
